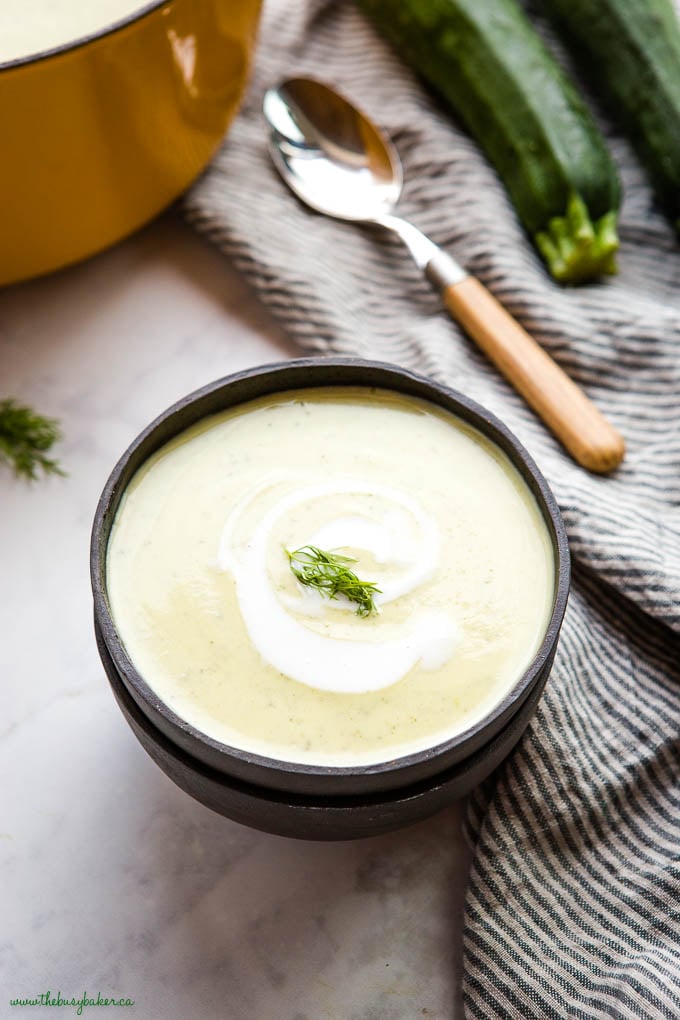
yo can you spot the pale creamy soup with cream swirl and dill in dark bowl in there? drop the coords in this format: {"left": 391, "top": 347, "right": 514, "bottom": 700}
{"left": 107, "top": 388, "right": 555, "bottom": 765}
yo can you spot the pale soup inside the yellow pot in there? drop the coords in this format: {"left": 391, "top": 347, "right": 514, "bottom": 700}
{"left": 0, "top": 0, "right": 150, "bottom": 63}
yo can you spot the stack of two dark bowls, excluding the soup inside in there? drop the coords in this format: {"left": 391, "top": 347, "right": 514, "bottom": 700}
{"left": 91, "top": 358, "right": 570, "bottom": 839}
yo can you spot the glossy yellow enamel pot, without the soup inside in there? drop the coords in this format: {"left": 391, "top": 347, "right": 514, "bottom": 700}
{"left": 0, "top": 0, "right": 261, "bottom": 284}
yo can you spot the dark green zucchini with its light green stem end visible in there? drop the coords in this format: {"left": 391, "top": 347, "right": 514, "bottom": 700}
{"left": 359, "top": 0, "right": 620, "bottom": 283}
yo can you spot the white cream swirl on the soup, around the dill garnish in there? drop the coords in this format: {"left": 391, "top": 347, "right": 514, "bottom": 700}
{"left": 218, "top": 479, "right": 457, "bottom": 694}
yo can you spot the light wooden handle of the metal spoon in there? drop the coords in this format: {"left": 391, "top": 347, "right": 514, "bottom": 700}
{"left": 442, "top": 276, "right": 626, "bottom": 472}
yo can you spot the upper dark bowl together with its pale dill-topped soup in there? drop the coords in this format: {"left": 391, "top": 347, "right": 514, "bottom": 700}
{"left": 92, "top": 358, "right": 569, "bottom": 836}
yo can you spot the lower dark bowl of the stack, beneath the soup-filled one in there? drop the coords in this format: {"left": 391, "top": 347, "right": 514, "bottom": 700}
{"left": 95, "top": 624, "right": 546, "bottom": 839}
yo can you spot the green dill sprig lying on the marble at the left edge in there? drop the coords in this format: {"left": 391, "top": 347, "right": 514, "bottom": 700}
{"left": 0, "top": 400, "right": 64, "bottom": 480}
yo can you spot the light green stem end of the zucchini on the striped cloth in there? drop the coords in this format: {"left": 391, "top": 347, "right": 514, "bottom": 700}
{"left": 534, "top": 194, "right": 619, "bottom": 284}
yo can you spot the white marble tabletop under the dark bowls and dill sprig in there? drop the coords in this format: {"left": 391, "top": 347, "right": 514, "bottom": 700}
{"left": 0, "top": 215, "right": 468, "bottom": 1020}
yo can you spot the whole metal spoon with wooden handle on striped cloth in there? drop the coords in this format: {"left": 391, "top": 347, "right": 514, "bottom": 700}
{"left": 264, "top": 78, "right": 625, "bottom": 472}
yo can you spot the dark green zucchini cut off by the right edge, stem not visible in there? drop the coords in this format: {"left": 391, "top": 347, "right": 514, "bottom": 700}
{"left": 541, "top": 0, "right": 680, "bottom": 230}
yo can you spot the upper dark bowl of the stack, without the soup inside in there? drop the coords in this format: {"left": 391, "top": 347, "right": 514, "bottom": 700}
{"left": 91, "top": 358, "right": 570, "bottom": 803}
